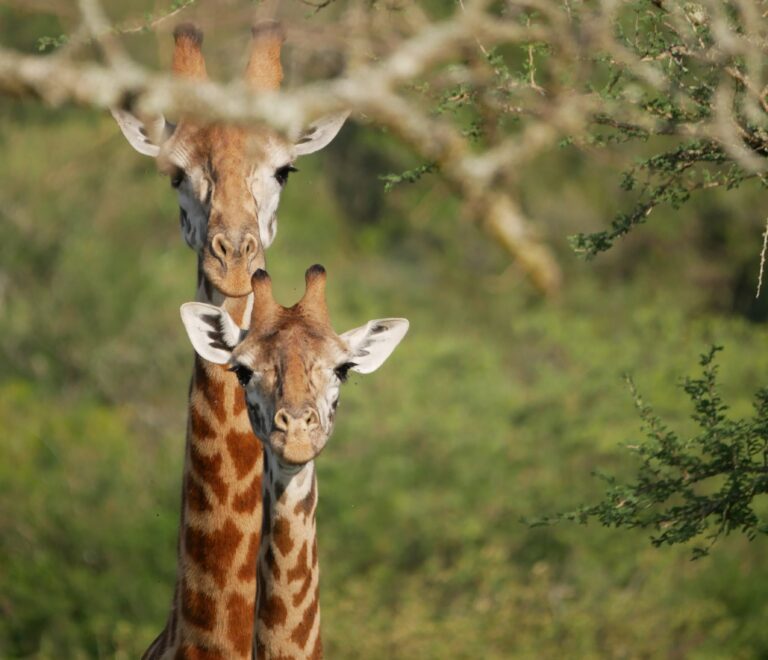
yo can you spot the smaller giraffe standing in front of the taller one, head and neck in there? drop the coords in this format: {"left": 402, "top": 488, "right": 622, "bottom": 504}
{"left": 181, "top": 266, "right": 408, "bottom": 660}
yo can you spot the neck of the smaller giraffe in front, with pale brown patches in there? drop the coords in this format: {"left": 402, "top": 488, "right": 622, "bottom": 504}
{"left": 255, "top": 447, "right": 323, "bottom": 660}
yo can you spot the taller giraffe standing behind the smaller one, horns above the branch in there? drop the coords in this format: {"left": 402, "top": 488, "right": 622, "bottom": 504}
{"left": 113, "top": 21, "right": 345, "bottom": 660}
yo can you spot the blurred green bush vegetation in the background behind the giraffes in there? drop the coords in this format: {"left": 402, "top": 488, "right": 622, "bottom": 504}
{"left": 0, "top": 2, "right": 768, "bottom": 659}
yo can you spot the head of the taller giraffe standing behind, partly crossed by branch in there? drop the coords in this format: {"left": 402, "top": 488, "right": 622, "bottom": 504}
{"left": 112, "top": 21, "right": 347, "bottom": 296}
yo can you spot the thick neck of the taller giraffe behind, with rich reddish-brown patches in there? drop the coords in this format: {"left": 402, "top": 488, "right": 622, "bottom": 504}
{"left": 144, "top": 276, "right": 263, "bottom": 660}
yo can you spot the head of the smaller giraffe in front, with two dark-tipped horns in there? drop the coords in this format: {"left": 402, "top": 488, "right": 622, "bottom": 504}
{"left": 181, "top": 266, "right": 408, "bottom": 466}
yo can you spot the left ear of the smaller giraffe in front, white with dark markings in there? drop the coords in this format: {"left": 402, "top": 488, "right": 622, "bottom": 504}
{"left": 181, "top": 303, "right": 240, "bottom": 364}
